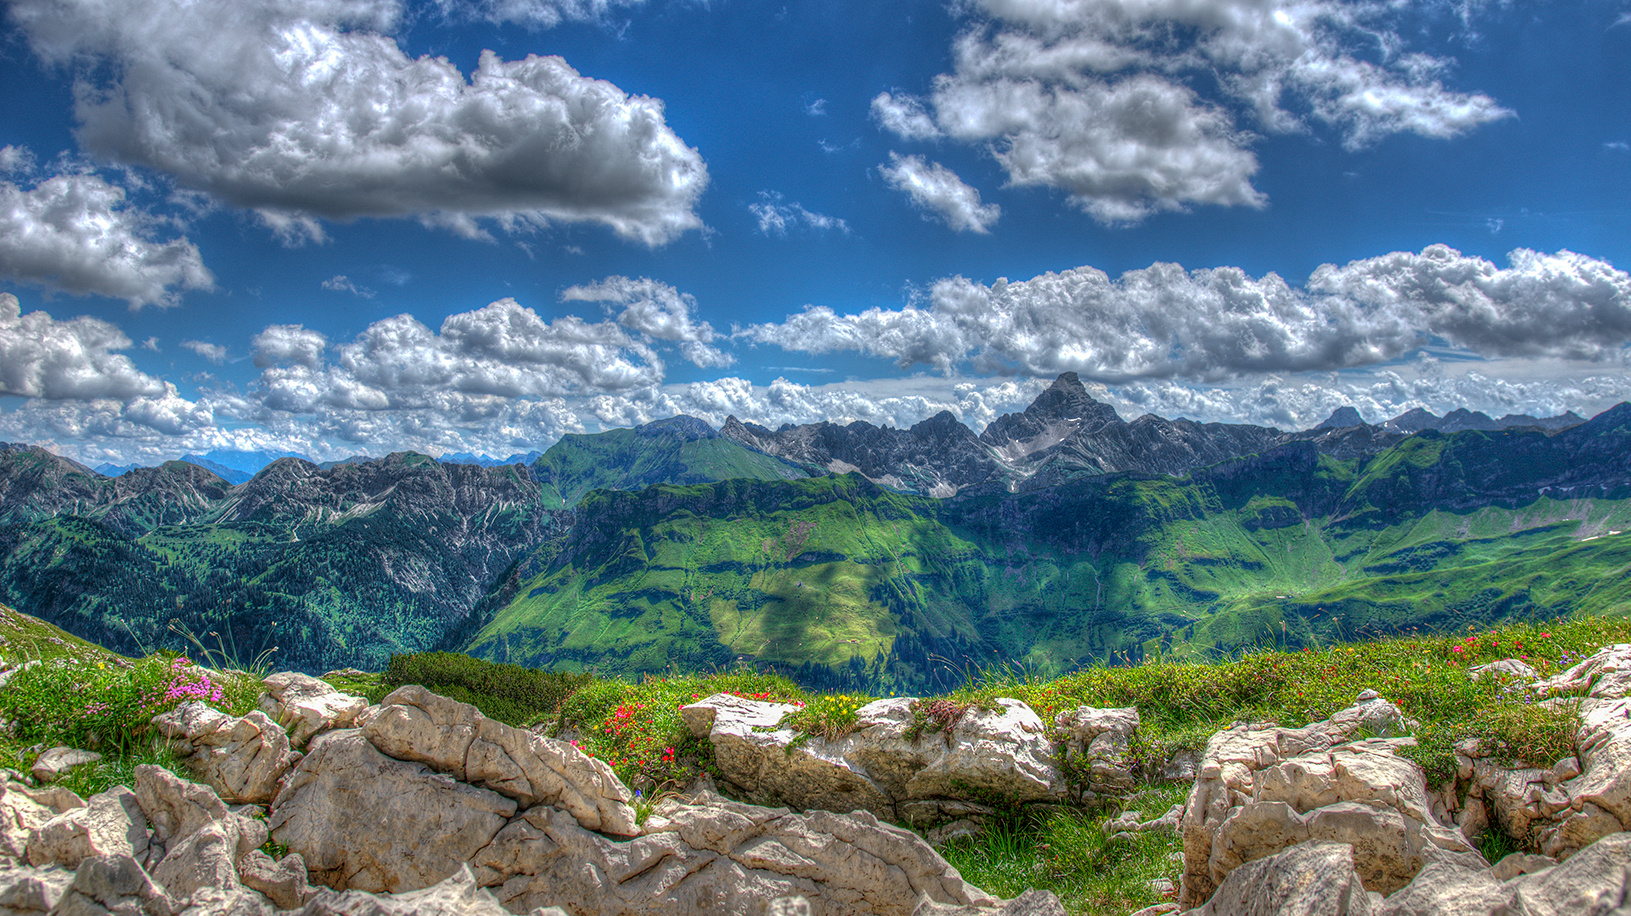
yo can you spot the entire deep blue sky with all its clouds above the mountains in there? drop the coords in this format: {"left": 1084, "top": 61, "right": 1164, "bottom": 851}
{"left": 0, "top": 0, "right": 1631, "bottom": 463}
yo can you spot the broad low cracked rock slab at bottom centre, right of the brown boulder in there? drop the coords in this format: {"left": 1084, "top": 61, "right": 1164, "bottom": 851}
{"left": 475, "top": 794, "right": 997, "bottom": 916}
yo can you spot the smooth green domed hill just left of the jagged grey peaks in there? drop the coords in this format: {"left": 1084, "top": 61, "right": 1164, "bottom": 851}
{"left": 532, "top": 417, "right": 809, "bottom": 507}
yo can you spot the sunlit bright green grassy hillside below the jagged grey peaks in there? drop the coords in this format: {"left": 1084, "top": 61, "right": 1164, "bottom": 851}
{"left": 466, "top": 437, "right": 1631, "bottom": 691}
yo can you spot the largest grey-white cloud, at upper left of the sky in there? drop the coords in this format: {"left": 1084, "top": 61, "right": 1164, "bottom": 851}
{"left": 8, "top": 0, "right": 708, "bottom": 244}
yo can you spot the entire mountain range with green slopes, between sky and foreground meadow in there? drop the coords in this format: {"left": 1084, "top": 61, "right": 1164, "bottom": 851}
{"left": 0, "top": 373, "right": 1631, "bottom": 693}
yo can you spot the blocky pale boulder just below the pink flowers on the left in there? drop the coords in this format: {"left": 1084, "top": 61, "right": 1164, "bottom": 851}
{"left": 153, "top": 702, "right": 300, "bottom": 805}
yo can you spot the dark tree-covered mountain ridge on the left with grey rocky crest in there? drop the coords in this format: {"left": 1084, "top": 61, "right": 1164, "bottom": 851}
{"left": 0, "top": 450, "right": 558, "bottom": 672}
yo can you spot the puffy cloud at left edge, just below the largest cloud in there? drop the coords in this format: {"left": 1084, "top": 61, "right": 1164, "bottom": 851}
{"left": 0, "top": 147, "right": 215, "bottom": 308}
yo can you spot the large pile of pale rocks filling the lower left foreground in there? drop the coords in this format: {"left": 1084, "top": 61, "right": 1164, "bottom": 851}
{"left": 0, "top": 678, "right": 1043, "bottom": 916}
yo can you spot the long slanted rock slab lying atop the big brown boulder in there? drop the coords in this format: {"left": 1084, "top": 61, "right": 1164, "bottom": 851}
{"left": 362, "top": 685, "right": 639, "bottom": 836}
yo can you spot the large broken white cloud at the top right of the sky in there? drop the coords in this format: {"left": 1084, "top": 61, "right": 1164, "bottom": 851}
{"left": 873, "top": 0, "right": 1510, "bottom": 225}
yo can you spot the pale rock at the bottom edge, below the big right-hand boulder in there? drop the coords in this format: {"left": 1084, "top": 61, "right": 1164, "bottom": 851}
{"left": 1191, "top": 843, "right": 1373, "bottom": 916}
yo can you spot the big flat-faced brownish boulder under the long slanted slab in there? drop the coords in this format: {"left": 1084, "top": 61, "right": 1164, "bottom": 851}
{"left": 269, "top": 729, "right": 515, "bottom": 893}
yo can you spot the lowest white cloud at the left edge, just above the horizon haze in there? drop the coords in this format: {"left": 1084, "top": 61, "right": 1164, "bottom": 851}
{"left": 0, "top": 293, "right": 166, "bottom": 396}
